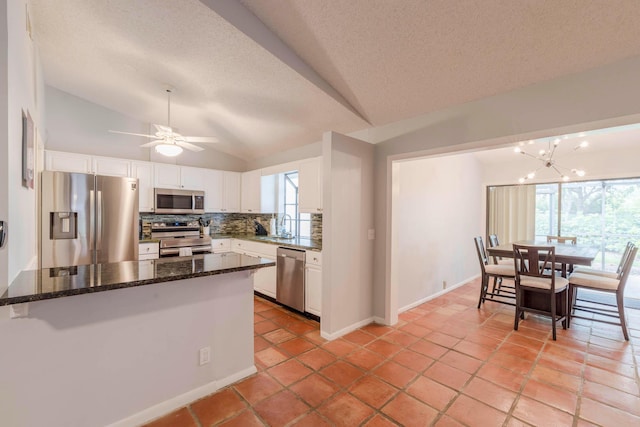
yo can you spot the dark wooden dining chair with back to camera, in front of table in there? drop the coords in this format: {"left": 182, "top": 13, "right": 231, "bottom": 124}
{"left": 513, "top": 244, "right": 569, "bottom": 341}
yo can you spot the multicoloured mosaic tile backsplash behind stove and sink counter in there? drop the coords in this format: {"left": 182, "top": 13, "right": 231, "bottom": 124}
{"left": 140, "top": 213, "right": 322, "bottom": 240}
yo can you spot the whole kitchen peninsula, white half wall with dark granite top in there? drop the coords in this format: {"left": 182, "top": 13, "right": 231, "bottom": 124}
{"left": 0, "top": 253, "right": 275, "bottom": 426}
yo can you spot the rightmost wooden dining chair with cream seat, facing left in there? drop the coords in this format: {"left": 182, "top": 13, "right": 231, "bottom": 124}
{"left": 569, "top": 244, "right": 638, "bottom": 341}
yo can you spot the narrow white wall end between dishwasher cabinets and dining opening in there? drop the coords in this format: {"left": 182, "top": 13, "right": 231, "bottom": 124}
{"left": 320, "top": 132, "right": 373, "bottom": 339}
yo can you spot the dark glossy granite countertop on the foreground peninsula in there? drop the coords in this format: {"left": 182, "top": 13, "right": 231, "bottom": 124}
{"left": 0, "top": 252, "right": 276, "bottom": 306}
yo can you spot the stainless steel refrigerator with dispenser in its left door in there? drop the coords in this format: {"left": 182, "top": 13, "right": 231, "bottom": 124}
{"left": 40, "top": 171, "right": 138, "bottom": 268}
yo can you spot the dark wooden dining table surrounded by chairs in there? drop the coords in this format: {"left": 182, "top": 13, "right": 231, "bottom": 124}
{"left": 487, "top": 239, "right": 600, "bottom": 277}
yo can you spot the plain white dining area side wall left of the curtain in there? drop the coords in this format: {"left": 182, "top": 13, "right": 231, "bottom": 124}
{"left": 391, "top": 154, "right": 484, "bottom": 311}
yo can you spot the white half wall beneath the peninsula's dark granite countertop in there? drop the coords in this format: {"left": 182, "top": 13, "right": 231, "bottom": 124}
{"left": 0, "top": 272, "right": 255, "bottom": 427}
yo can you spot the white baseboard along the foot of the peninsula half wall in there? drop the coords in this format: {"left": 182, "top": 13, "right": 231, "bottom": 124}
{"left": 107, "top": 366, "right": 257, "bottom": 427}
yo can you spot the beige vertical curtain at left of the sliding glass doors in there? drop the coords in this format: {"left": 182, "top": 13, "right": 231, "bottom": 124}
{"left": 488, "top": 185, "right": 536, "bottom": 244}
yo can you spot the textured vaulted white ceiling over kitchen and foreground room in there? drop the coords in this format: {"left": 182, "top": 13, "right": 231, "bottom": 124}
{"left": 29, "top": 0, "right": 640, "bottom": 160}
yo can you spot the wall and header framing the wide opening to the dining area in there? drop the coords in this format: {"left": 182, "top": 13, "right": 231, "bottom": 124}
{"left": 367, "top": 57, "right": 640, "bottom": 322}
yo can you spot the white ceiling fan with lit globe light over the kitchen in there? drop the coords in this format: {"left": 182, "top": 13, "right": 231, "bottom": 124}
{"left": 109, "top": 89, "right": 220, "bottom": 157}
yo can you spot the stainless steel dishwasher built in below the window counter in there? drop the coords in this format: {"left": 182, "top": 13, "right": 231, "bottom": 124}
{"left": 276, "top": 247, "right": 305, "bottom": 312}
